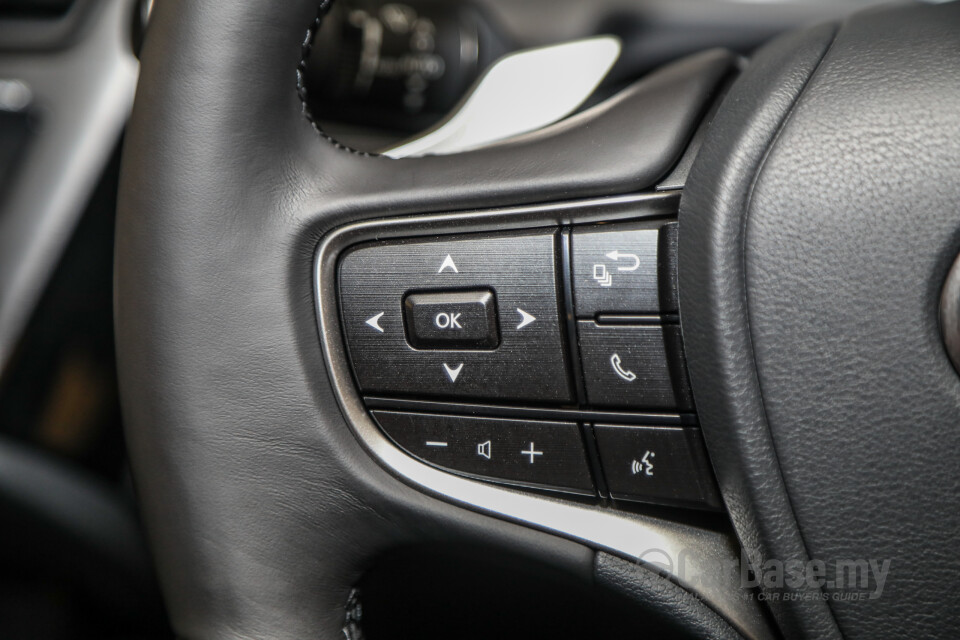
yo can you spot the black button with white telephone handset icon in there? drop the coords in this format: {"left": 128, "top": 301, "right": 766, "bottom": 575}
{"left": 577, "top": 320, "right": 693, "bottom": 411}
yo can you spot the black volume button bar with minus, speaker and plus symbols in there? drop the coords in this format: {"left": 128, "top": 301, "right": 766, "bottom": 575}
{"left": 373, "top": 411, "right": 594, "bottom": 495}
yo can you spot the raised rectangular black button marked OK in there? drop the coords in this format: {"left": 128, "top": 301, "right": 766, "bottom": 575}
{"left": 403, "top": 289, "right": 500, "bottom": 349}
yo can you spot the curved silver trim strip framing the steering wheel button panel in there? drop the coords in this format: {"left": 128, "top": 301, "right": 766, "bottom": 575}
{"left": 314, "top": 191, "right": 774, "bottom": 638}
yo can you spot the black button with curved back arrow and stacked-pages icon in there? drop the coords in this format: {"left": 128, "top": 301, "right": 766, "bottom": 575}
{"left": 571, "top": 223, "right": 677, "bottom": 318}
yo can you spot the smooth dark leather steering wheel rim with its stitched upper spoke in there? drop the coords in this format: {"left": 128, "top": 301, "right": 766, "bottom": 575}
{"left": 116, "top": 0, "right": 732, "bottom": 638}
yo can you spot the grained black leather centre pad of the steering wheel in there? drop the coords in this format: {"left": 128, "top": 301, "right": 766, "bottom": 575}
{"left": 680, "top": 3, "right": 960, "bottom": 638}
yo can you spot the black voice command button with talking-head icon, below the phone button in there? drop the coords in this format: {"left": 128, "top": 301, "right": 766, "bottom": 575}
{"left": 594, "top": 424, "right": 720, "bottom": 508}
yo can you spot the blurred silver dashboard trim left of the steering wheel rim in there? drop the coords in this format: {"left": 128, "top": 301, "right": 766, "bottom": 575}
{"left": 0, "top": 0, "right": 139, "bottom": 372}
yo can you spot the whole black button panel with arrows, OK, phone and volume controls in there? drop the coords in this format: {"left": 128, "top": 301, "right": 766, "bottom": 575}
{"left": 324, "top": 195, "right": 720, "bottom": 509}
